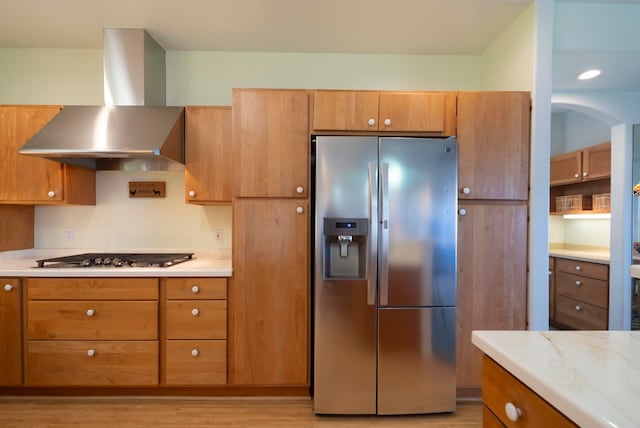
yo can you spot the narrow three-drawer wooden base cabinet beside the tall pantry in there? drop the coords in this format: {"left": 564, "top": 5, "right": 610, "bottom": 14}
{"left": 163, "top": 278, "right": 227, "bottom": 385}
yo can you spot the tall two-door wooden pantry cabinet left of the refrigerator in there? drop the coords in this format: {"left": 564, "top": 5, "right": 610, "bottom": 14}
{"left": 229, "top": 89, "right": 310, "bottom": 388}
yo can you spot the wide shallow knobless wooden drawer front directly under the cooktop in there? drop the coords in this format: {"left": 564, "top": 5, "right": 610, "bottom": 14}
{"left": 27, "top": 278, "right": 159, "bottom": 300}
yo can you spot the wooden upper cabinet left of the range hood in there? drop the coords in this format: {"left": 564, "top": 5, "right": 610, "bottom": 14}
{"left": 0, "top": 106, "right": 96, "bottom": 205}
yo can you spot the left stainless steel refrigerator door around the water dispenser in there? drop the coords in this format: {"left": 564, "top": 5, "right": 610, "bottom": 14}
{"left": 314, "top": 137, "right": 378, "bottom": 414}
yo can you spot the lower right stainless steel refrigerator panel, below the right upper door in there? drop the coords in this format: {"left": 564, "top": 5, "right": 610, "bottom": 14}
{"left": 378, "top": 308, "right": 456, "bottom": 415}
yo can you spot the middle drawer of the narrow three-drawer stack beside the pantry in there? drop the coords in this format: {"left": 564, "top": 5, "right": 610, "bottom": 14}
{"left": 166, "top": 300, "right": 227, "bottom": 339}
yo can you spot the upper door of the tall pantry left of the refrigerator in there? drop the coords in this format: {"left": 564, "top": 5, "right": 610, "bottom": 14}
{"left": 233, "top": 89, "right": 310, "bottom": 198}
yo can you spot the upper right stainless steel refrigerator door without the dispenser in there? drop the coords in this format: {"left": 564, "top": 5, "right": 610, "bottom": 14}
{"left": 379, "top": 137, "right": 458, "bottom": 307}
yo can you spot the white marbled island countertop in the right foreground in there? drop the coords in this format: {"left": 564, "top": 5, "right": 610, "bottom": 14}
{"left": 472, "top": 331, "right": 640, "bottom": 428}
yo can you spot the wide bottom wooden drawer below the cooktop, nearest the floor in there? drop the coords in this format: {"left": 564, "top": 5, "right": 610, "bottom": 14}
{"left": 25, "top": 340, "right": 158, "bottom": 386}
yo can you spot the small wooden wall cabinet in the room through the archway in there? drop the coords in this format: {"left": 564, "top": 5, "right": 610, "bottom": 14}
{"left": 550, "top": 142, "right": 611, "bottom": 186}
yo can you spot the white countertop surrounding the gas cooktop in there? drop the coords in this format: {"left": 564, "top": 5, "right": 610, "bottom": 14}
{"left": 0, "top": 248, "right": 233, "bottom": 277}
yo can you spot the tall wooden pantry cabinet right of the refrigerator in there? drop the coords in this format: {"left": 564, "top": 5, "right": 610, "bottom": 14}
{"left": 457, "top": 92, "right": 531, "bottom": 394}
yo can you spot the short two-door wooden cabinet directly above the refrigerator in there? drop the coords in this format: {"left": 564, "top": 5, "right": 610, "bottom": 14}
{"left": 313, "top": 91, "right": 456, "bottom": 135}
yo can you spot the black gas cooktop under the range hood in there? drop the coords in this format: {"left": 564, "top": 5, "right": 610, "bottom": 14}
{"left": 36, "top": 253, "right": 193, "bottom": 268}
